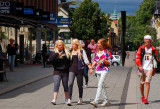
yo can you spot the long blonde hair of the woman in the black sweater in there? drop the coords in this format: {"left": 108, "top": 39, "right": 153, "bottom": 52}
{"left": 54, "top": 40, "right": 70, "bottom": 59}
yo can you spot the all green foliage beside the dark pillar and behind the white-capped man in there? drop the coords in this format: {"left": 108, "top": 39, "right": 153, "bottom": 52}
{"left": 119, "top": 0, "right": 158, "bottom": 46}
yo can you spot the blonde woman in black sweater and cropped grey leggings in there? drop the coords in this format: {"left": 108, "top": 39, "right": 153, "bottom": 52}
{"left": 49, "top": 40, "right": 70, "bottom": 105}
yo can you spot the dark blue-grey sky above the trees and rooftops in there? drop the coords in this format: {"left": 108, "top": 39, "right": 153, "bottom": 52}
{"left": 59, "top": 0, "right": 143, "bottom": 17}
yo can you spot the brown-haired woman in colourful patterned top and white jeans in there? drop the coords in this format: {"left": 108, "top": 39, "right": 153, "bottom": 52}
{"left": 90, "top": 39, "right": 112, "bottom": 107}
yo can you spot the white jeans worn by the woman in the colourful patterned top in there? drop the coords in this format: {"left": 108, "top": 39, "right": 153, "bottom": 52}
{"left": 94, "top": 73, "right": 108, "bottom": 103}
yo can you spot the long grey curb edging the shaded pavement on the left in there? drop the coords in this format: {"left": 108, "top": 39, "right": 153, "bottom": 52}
{"left": 0, "top": 73, "right": 53, "bottom": 95}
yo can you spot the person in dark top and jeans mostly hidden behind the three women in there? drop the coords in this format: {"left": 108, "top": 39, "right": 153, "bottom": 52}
{"left": 82, "top": 41, "right": 91, "bottom": 88}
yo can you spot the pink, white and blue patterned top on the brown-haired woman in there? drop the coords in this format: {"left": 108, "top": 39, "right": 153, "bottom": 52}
{"left": 94, "top": 50, "right": 113, "bottom": 71}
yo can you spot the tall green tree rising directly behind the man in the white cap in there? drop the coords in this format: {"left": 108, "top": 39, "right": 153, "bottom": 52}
{"left": 134, "top": 0, "right": 157, "bottom": 45}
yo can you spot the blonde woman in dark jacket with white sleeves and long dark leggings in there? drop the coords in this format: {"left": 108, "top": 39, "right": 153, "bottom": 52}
{"left": 68, "top": 39, "right": 91, "bottom": 106}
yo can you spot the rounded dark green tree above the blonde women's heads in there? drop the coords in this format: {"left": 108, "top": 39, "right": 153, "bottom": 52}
{"left": 69, "top": 0, "right": 108, "bottom": 40}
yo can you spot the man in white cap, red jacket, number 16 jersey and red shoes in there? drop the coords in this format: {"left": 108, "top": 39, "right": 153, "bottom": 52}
{"left": 136, "top": 35, "right": 158, "bottom": 104}
